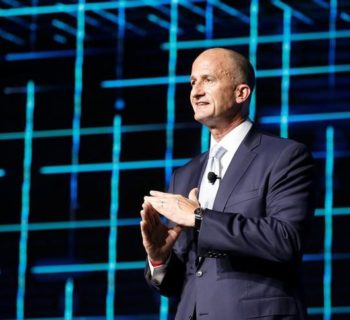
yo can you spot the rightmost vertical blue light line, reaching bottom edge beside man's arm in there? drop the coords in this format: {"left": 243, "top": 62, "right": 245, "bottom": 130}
{"left": 323, "top": 127, "right": 334, "bottom": 320}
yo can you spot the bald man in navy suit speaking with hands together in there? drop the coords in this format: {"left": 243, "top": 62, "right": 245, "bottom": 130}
{"left": 141, "top": 48, "right": 313, "bottom": 320}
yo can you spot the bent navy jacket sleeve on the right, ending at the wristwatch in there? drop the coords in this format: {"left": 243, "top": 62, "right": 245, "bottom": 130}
{"left": 198, "top": 143, "right": 314, "bottom": 262}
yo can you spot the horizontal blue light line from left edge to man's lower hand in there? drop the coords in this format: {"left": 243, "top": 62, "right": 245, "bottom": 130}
{"left": 0, "top": 218, "right": 140, "bottom": 233}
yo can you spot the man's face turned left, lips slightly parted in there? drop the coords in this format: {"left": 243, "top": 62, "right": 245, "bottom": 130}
{"left": 190, "top": 53, "right": 240, "bottom": 127}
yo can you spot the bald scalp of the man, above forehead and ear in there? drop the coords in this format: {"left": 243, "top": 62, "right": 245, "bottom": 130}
{"left": 195, "top": 48, "right": 255, "bottom": 92}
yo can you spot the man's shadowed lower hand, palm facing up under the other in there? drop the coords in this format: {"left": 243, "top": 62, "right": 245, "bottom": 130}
{"left": 140, "top": 202, "right": 182, "bottom": 264}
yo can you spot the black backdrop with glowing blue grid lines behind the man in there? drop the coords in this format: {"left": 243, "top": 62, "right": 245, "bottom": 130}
{"left": 0, "top": 0, "right": 350, "bottom": 320}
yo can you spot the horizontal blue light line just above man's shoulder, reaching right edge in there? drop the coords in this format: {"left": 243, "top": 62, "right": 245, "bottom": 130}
{"left": 260, "top": 111, "right": 350, "bottom": 124}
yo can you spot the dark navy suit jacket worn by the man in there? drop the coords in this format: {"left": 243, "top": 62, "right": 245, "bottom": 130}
{"left": 146, "top": 126, "right": 314, "bottom": 320}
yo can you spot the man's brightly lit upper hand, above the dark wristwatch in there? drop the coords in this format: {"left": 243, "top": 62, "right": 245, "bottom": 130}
{"left": 145, "top": 188, "right": 200, "bottom": 227}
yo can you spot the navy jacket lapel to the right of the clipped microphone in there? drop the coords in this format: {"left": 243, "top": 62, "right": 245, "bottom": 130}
{"left": 213, "top": 126, "right": 261, "bottom": 211}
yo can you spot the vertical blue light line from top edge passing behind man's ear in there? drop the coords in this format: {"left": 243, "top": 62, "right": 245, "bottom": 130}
{"left": 249, "top": 0, "right": 259, "bottom": 121}
